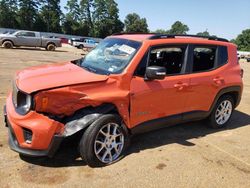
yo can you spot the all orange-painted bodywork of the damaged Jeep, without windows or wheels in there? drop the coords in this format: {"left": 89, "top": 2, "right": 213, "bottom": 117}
{"left": 7, "top": 35, "right": 242, "bottom": 149}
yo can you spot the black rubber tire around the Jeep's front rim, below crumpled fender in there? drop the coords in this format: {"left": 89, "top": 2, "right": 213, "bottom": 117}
{"left": 79, "top": 114, "right": 129, "bottom": 167}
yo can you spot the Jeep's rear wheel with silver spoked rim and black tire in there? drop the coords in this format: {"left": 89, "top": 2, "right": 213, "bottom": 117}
{"left": 208, "top": 95, "right": 235, "bottom": 128}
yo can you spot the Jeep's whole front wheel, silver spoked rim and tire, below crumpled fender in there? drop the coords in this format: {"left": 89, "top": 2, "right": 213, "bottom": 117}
{"left": 79, "top": 114, "right": 129, "bottom": 167}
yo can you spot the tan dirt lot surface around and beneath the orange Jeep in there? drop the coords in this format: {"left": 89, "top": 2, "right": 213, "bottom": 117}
{"left": 0, "top": 47, "right": 250, "bottom": 187}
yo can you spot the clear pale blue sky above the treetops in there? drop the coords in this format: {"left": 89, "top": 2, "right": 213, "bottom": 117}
{"left": 61, "top": 0, "right": 250, "bottom": 39}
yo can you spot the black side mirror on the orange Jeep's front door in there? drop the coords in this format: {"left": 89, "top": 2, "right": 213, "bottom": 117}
{"left": 145, "top": 66, "right": 166, "bottom": 80}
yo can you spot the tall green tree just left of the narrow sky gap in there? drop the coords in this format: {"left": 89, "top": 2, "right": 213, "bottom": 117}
{"left": 40, "top": 0, "right": 62, "bottom": 33}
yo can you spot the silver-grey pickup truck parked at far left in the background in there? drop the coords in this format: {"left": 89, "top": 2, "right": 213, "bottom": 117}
{"left": 0, "top": 31, "right": 62, "bottom": 51}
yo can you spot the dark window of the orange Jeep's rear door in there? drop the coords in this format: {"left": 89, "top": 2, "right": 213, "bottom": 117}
{"left": 193, "top": 46, "right": 217, "bottom": 72}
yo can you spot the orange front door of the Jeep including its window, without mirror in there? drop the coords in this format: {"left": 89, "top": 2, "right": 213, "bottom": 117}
{"left": 130, "top": 45, "right": 189, "bottom": 127}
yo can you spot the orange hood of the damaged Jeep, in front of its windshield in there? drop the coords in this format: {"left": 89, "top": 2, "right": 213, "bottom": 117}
{"left": 16, "top": 62, "right": 108, "bottom": 93}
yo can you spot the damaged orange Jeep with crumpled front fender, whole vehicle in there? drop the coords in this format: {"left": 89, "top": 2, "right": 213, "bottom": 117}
{"left": 5, "top": 33, "right": 243, "bottom": 167}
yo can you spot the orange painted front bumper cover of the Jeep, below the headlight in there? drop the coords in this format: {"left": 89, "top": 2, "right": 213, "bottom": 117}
{"left": 6, "top": 93, "right": 64, "bottom": 150}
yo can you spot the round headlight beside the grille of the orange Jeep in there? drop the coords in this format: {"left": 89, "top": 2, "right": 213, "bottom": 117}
{"left": 12, "top": 85, "right": 32, "bottom": 115}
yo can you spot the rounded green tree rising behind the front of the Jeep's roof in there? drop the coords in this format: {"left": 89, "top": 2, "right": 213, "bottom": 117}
{"left": 124, "top": 13, "right": 149, "bottom": 33}
